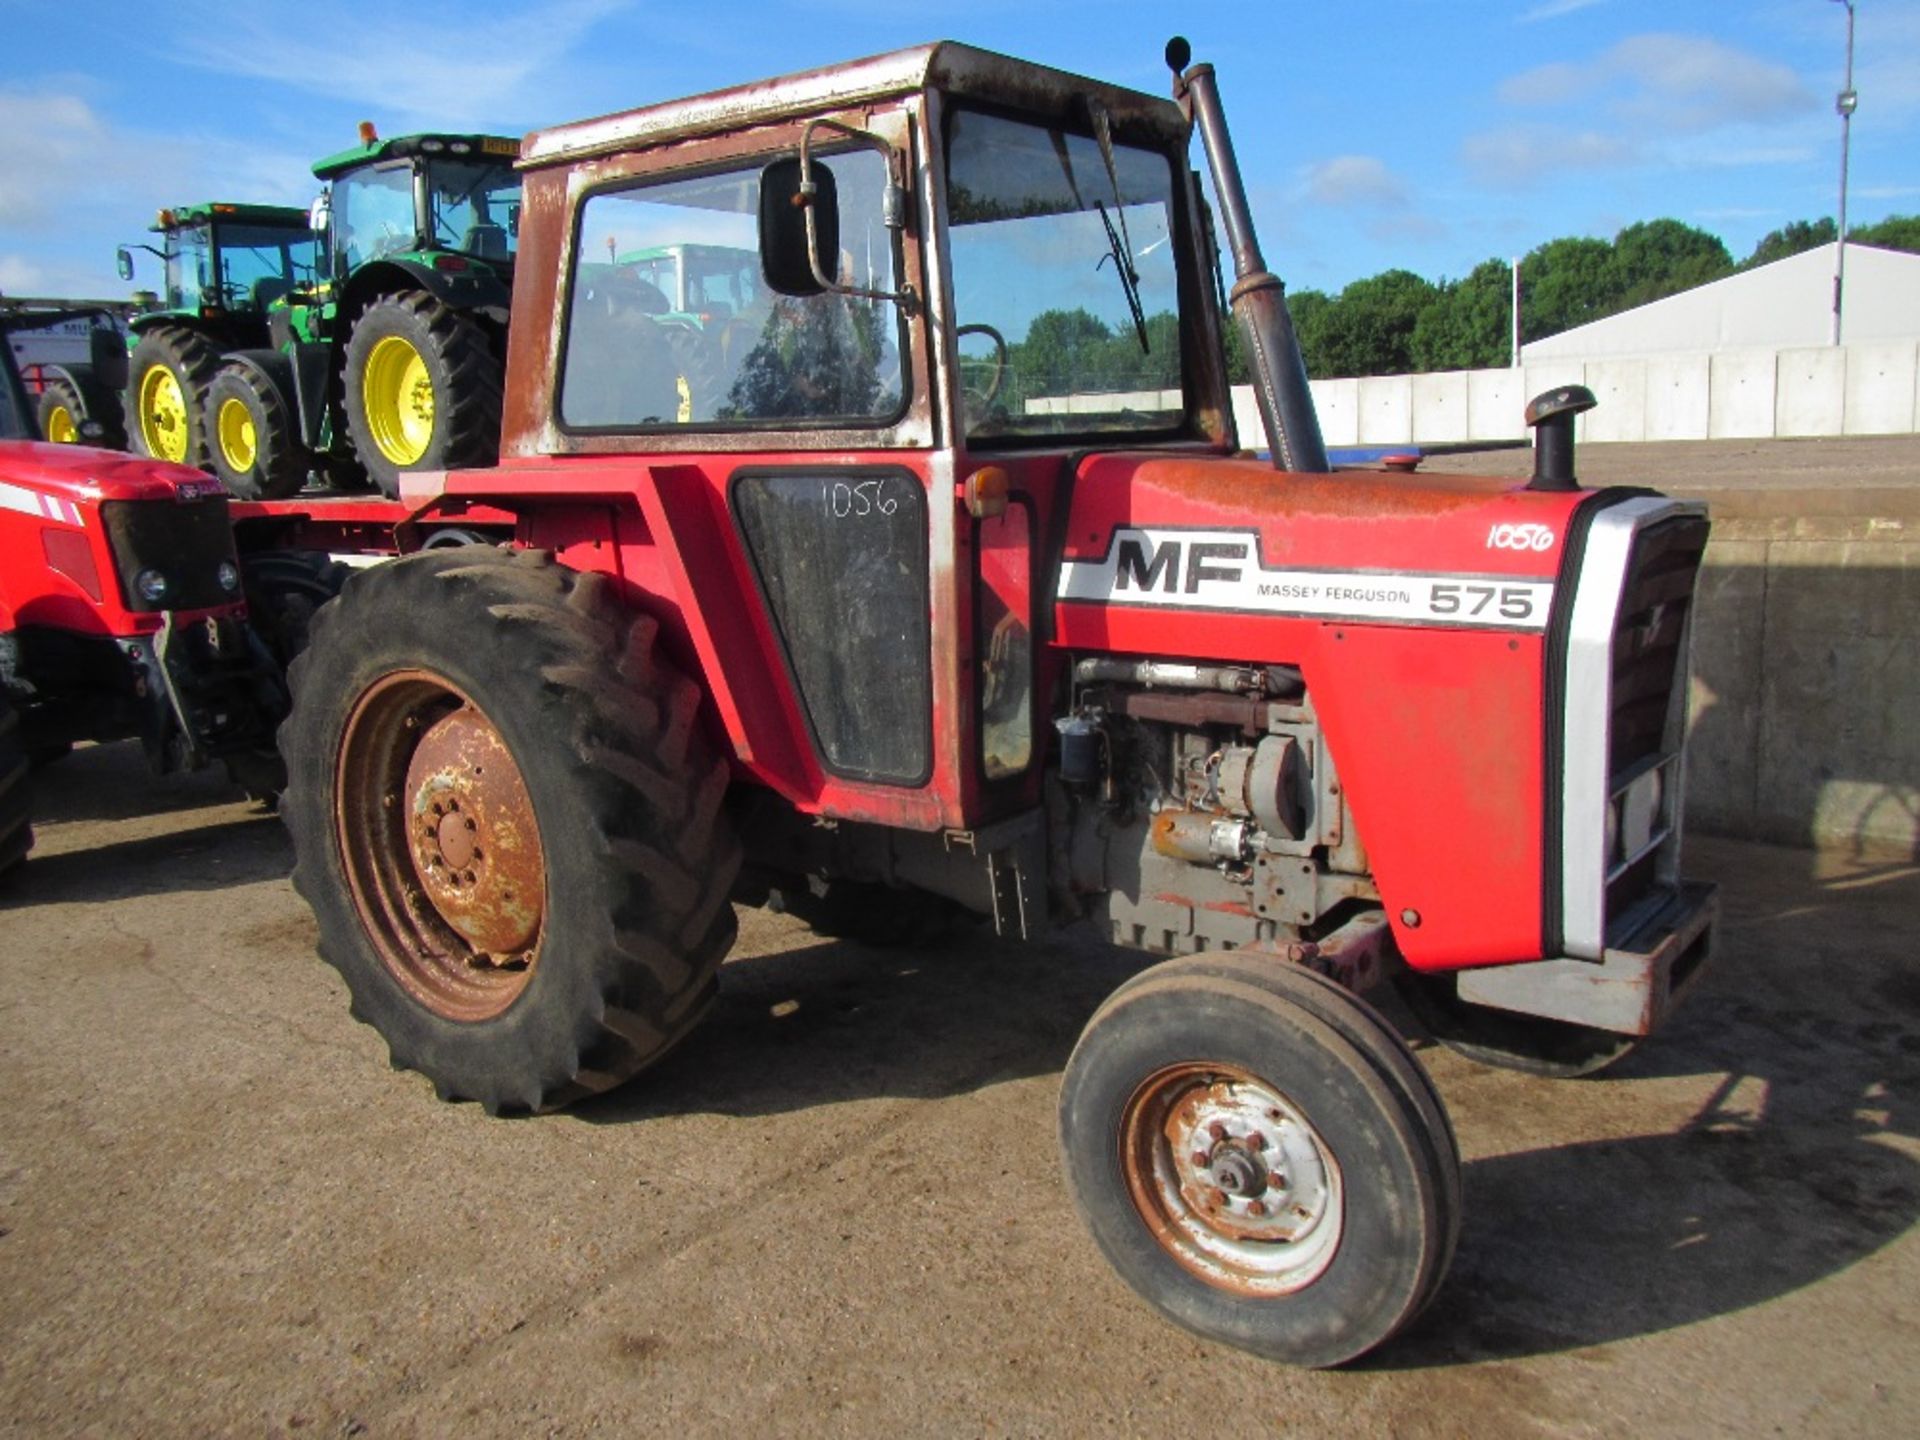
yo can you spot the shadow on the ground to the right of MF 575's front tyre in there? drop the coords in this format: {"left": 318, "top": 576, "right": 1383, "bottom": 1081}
{"left": 1363, "top": 843, "right": 1920, "bottom": 1371}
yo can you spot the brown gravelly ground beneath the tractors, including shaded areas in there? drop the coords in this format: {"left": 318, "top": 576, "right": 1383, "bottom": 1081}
{"left": 0, "top": 745, "right": 1920, "bottom": 1436}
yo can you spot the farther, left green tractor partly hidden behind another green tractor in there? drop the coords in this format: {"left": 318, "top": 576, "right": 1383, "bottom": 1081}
{"left": 115, "top": 204, "right": 315, "bottom": 470}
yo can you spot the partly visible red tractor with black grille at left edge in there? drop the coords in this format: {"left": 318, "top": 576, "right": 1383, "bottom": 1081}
{"left": 0, "top": 301, "right": 291, "bottom": 872}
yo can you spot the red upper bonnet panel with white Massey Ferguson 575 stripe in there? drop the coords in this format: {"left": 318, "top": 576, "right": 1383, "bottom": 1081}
{"left": 1054, "top": 453, "right": 1592, "bottom": 636}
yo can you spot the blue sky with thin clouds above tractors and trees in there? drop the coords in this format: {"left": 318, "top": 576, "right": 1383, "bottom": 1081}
{"left": 0, "top": 0, "right": 1920, "bottom": 298}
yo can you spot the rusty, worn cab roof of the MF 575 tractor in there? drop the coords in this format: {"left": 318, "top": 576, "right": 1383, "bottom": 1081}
{"left": 520, "top": 40, "right": 1187, "bottom": 169}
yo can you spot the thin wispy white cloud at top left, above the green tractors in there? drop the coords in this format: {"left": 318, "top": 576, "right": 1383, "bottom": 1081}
{"left": 169, "top": 0, "right": 620, "bottom": 131}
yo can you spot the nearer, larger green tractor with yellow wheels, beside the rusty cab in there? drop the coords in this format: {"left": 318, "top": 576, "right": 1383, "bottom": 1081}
{"left": 209, "top": 125, "right": 520, "bottom": 497}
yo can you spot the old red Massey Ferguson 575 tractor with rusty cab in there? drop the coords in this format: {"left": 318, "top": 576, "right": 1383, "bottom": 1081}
{"left": 280, "top": 42, "right": 1715, "bottom": 1365}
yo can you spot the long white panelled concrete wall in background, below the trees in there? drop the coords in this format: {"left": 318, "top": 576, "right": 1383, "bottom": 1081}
{"left": 1235, "top": 340, "right": 1920, "bottom": 447}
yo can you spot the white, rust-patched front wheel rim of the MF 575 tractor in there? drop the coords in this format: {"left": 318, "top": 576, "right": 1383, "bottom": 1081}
{"left": 1119, "top": 1062, "right": 1346, "bottom": 1298}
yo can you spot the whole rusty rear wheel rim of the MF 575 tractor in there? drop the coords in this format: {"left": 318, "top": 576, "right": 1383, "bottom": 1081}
{"left": 334, "top": 670, "right": 545, "bottom": 1023}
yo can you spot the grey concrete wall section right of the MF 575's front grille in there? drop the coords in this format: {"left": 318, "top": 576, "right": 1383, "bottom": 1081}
{"left": 1688, "top": 490, "right": 1920, "bottom": 860}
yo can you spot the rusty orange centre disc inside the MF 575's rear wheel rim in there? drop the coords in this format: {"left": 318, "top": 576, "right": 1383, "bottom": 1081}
{"left": 405, "top": 707, "right": 543, "bottom": 964}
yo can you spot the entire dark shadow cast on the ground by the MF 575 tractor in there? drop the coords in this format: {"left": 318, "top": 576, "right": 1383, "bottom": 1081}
{"left": 576, "top": 843, "right": 1920, "bottom": 1371}
